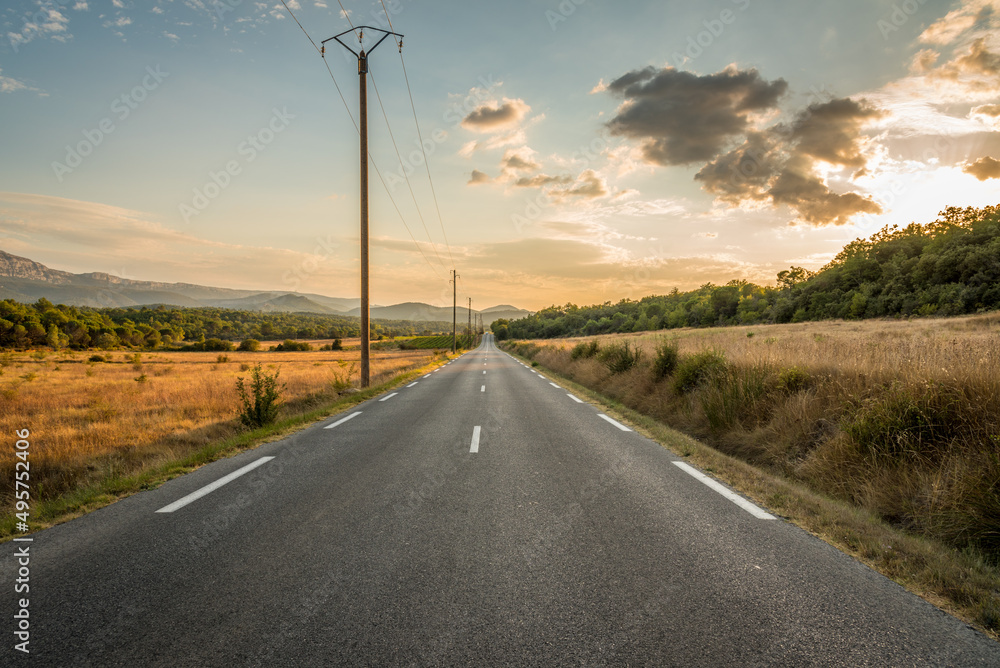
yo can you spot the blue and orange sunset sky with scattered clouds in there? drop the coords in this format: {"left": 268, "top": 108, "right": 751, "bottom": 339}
{"left": 0, "top": 0, "right": 1000, "bottom": 310}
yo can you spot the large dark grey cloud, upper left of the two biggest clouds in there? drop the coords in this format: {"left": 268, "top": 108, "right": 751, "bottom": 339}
{"left": 607, "top": 66, "right": 788, "bottom": 166}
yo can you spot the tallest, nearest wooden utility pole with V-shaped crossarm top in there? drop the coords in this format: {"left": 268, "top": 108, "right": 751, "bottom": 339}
{"left": 320, "top": 26, "right": 403, "bottom": 387}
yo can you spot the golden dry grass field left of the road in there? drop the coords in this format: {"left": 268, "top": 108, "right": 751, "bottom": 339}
{"left": 0, "top": 340, "right": 435, "bottom": 520}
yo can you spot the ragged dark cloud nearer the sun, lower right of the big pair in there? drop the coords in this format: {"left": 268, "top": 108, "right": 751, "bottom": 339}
{"left": 695, "top": 98, "right": 883, "bottom": 225}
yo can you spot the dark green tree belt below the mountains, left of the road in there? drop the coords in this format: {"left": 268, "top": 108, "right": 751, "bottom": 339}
{"left": 0, "top": 299, "right": 451, "bottom": 350}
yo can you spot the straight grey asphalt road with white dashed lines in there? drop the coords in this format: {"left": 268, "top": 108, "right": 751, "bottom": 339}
{"left": 0, "top": 337, "right": 1000, "bottom": 667}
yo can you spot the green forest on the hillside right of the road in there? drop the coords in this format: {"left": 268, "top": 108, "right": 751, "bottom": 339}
{"left": 491, "top": 206, "right": 1000, "bottom": 340}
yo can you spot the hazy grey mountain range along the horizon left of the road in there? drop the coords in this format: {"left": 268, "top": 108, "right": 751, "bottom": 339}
{"left": 0, "top": 250, "right": 530, "bottom": 325}
